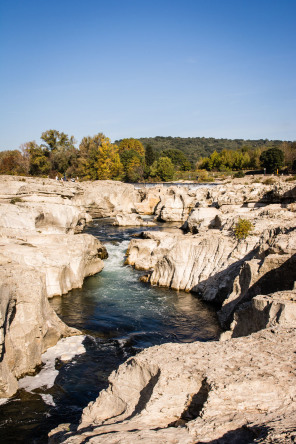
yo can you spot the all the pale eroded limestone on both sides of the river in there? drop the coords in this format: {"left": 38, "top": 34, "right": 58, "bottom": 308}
{"left": 0, "top": 176, "right": 296, "bottom": 444}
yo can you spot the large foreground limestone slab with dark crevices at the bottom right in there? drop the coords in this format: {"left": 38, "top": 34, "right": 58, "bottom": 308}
{"left": 50, "top": 327, "right": 296, "bottom": 444}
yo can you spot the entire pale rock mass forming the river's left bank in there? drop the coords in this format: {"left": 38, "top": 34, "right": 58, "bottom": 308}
{"left": 0, "top": 176, "right": 107, "bottom": 398}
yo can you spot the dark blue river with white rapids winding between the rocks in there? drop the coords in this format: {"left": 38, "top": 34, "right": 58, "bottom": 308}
{"left": 0, "top": 219, "right": 219, "bottom": 444}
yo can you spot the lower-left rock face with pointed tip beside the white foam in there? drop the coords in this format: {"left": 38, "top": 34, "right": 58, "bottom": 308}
{"left": 0, "top": 262, "right": 78, "bottom": 398}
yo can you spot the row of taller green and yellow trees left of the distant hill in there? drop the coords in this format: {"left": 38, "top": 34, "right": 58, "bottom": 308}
{"left": 0, "top": 130, "right": 191, "bottom": 182}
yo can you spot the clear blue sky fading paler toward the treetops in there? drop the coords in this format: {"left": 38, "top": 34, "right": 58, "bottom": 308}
{"left": 0, "top": 0, "right": 296, "bottom": 150}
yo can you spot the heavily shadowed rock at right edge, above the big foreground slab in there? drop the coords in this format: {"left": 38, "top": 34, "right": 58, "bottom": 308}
{"left": 218, "top": 230, "right": 296, "bottom": 337}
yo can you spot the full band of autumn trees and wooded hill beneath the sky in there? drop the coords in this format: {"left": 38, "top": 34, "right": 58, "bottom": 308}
{"left": 0, "top": 130, "right": 296, "bottom": 182}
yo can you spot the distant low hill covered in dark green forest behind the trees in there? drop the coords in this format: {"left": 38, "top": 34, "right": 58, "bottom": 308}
{"left": 138, "top": 136, "right": 283, "bottom": 164}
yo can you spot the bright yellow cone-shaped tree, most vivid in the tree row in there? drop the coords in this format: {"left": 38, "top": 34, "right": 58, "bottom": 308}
{"left": 96, "top": 137, "right": 123, "bottom": 180}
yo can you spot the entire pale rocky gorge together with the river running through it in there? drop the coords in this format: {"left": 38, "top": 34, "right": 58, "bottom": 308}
{"left": 0, "top": 176, "right": 296, "bottom": 444}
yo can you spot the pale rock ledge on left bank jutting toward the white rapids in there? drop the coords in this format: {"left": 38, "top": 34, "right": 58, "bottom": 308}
{"left": 0, "top": 234, "right": 106, "bottom": 297}
